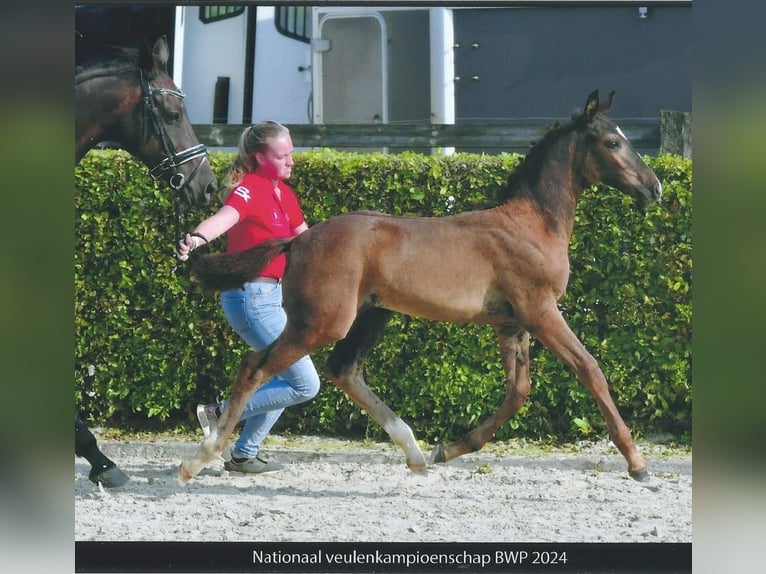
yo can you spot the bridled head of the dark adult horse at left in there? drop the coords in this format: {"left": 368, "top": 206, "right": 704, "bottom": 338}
{"left": 123, "top": 36, "right": 218, "bottom": 210}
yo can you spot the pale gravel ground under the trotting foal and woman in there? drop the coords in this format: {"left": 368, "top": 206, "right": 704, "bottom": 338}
{"left": 74, "top": 437, "right": 692, "bottom": 542}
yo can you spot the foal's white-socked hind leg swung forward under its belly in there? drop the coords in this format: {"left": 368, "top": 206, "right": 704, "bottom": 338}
{"left": 327, "top": 307, "right": 426, "bottom": 474}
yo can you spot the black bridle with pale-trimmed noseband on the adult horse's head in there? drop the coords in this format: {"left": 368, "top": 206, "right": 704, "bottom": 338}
{"left": 138, "top": 68, "right": 207, "bottom": 191}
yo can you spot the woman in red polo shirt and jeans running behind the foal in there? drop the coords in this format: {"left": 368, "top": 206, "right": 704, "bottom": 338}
{"left": 177, "top": 121, "right": 319, "bottom": 473}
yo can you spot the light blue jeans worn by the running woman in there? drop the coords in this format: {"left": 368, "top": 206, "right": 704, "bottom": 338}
{"left": 221, "top": 281, "right": 319, "bottom": 458}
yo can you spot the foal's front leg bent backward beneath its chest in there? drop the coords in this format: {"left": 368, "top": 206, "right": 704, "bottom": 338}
{"left": 431, "top": 326, "right": 531, "bottom": 463}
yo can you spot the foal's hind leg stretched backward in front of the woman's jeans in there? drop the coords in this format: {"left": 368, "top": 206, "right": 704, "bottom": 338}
{"left": 178, "top": 338, "right": 307, "bottom": 485}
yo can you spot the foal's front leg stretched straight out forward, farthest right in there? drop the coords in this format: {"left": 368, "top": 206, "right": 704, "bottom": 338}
{"left": 533, "top": 306, "right": 649, "bottom": 481}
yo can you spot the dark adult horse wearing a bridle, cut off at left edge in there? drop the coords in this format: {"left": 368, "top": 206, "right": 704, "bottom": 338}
{"left": 75, "top": 36, "right": 217, "bottom": 488}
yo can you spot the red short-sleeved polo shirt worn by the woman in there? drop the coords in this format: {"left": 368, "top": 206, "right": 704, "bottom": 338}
{"left": 224, "top": 173, "right": 305, "bottom": 279}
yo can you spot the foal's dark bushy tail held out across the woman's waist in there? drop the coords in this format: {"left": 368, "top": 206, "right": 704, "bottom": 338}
{"left": 189, "top": 238, "right": 292, "bottom": 291}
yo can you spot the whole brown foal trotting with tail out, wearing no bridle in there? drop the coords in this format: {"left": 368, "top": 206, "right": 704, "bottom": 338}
{"left": 179, "top": 92, "right": 662, "bottom": 484}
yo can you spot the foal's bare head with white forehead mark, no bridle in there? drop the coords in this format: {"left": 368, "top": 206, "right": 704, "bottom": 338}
{"left": 578, "top": 90, "right": 662, "bottom": 209}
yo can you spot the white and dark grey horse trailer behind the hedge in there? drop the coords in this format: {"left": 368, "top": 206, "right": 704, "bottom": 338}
{"left": 75, "top": 4, "right": 692, "bottom": 142}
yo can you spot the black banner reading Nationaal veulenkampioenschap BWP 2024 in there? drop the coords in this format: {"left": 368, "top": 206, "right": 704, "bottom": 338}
{"left": 75, "top": 542, "right": 692, "bottom": 574}
